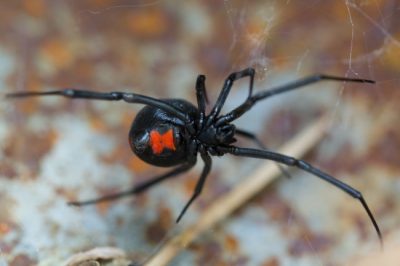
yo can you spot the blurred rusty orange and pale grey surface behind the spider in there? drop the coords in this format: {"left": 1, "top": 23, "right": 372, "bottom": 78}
{"left": 0, "top": 0, "right": 400, "bottom": 266}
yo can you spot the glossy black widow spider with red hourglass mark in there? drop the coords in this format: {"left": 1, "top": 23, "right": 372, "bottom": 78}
{"left": 6, "top": 68, "right": 382, "bottom": 243}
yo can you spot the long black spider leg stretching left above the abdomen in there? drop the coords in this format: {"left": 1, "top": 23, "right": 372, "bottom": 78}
{"left": 6, "top": 89, "right": 191, "bottom": 124}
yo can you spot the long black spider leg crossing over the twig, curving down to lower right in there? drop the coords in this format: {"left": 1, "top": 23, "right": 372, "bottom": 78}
{"left": 218, "top": 146, "right": 383, "bottom": 246}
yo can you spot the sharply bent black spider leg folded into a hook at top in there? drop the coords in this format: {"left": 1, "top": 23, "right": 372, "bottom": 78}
{"left": 207, "top": 68, "right": 255, "bottom": 125}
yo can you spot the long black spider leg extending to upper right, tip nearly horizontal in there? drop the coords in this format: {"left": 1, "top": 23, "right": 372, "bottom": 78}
{"left": 216, "top": 74, "right": 375, "bottom": 125}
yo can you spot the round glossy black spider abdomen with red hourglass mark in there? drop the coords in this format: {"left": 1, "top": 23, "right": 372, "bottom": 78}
{"left": 129, "top": 99, "right": 196, "bottom": 167}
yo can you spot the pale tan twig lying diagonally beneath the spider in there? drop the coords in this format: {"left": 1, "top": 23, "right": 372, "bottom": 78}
{"left": 145, "top": 116, "right": 328, "bottom": 266}
